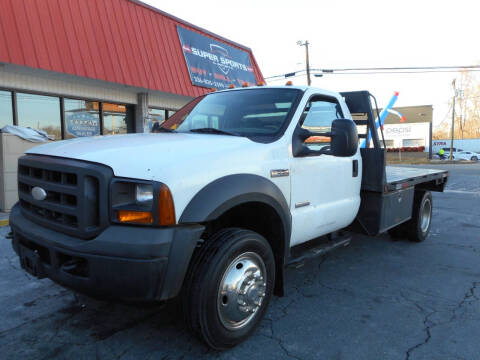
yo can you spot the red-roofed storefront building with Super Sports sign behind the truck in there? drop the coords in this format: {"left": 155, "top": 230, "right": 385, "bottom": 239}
{"left": 0, "top": 0, "right": 264, "bottom": 138}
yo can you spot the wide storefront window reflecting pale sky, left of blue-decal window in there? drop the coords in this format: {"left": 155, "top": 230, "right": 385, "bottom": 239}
{"left": 17, "top": 93, "right": 62, "bottom": 140}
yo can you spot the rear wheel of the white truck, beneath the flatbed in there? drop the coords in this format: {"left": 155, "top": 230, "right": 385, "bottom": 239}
{"left": 405, "top": 190, "right": 433, "bottom": 242}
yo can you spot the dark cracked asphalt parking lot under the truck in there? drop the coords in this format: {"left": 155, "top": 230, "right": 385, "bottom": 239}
{"left": 0, "top": 164, "right": 480, "bottom": 360}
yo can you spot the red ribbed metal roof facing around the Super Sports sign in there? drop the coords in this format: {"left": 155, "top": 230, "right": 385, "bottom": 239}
{"left": 0, "top": 0, "right": 264, "bottom": 96}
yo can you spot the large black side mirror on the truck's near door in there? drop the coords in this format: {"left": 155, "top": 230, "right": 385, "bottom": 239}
{"left": 330, "top": 119, "right": 358, "bottom": 157}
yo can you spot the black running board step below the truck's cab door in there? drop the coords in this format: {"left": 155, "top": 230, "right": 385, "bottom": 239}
{"left": 287, "top": 234, "right": 352, "bottom": 267}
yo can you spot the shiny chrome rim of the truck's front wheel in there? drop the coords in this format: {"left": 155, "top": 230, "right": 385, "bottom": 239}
{"left": 217, "top": 252, "right": 267, "bottom": 330}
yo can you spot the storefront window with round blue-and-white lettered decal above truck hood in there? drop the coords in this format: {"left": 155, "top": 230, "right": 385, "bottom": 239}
{"left": 64, "top": 99, "right": 100, "bottom": 139}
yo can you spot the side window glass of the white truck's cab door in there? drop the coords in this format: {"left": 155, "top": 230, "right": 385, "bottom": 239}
{"left": 301, "top": 98, "right": 343, "bottom": 150}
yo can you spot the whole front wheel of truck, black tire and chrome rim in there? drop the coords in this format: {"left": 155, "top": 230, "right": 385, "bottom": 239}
{"left": 183, "top": 228, "right": 275, "bottom": 350}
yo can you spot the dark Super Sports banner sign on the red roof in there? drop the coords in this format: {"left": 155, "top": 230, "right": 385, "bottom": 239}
{"left": 177, "top": 26, "right": 256, "bottom": 90}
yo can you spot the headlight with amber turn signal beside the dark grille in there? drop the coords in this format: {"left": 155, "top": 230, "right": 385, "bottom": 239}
{"left": 111, "top": 179, "right": 175, "bottom": 226}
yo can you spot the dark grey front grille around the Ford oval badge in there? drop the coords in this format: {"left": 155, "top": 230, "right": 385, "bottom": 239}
{"left": 18, "top": 155, "right": 112, "bottom": 239}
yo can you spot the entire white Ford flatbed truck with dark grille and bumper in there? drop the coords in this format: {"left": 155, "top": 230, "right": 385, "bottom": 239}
{"left": 10, "top": 86, "right": 448, "bottom": 349}
